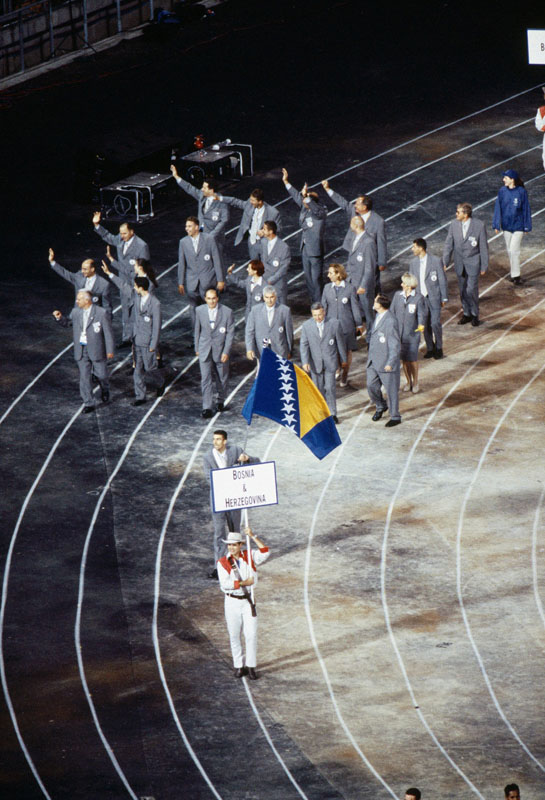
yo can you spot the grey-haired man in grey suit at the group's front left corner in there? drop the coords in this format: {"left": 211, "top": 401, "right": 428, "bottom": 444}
{"left": 53, "top": 289, "right": 114, "bottom": 413}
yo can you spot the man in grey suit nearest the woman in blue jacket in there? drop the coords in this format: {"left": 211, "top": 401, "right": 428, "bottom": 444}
{"left": 443, "top": 203, "right": 488, "bottom": 327}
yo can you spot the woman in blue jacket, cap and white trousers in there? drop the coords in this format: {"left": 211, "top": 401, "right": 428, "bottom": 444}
{"left": 492, "top": 169, "right": 532, "bottom": 286}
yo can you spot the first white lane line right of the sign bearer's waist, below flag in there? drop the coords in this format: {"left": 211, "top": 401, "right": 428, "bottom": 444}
{"left": 303, "top": 405, "right": 397, "bottom": 798}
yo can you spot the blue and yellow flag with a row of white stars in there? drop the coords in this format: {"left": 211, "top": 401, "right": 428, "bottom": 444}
{"left": 242, "top": 347, "right": 341, "bottom": 459}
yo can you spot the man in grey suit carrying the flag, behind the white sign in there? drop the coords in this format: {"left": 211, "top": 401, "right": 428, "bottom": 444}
{"left": 203, "top": 430, "right": 259, "bottom": 578}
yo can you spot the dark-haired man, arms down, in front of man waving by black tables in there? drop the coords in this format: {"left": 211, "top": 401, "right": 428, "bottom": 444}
{"left": 178, "top": 217, "right": 225, "bottom": 327}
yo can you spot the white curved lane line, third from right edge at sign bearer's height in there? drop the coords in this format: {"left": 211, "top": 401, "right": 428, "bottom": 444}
{"left": 380, "top": 292, "right": 545, "bottom": 800}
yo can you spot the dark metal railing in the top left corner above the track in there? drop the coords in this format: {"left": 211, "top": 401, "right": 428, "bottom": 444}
{"left": 0, "top": 0, "right": 154, "bottom": 79}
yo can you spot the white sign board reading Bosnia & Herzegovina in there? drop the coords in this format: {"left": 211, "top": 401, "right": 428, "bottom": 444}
{"left": 210, "top": 461, "right": 278, "bottom": 511}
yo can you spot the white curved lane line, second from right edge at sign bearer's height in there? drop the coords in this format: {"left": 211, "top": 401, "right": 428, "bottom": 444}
{"left": 456, "top": 362, "right": 545, "bottom": 772}
